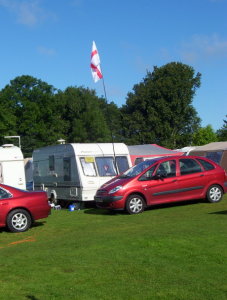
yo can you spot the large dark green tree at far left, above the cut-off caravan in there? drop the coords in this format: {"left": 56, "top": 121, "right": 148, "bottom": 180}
{"left": 0, "top": 75, "right": 64, "bottom": 156}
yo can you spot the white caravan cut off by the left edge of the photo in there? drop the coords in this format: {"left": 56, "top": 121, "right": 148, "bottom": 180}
{"left": 0, "top": 144, "right": 26, "bottom": 189}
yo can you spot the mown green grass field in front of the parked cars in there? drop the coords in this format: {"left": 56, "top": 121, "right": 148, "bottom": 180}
{"left": 0, "top": 195, "right": 227, "bottom": 300}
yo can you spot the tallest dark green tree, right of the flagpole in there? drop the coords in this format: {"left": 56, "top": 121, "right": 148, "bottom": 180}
{"left": 122, "top": 62, "right": 201, "bottom": 148}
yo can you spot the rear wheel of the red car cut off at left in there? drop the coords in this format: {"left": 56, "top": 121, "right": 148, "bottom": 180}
{"left": 6, "top": 209, "right": 32, "bottom": 232}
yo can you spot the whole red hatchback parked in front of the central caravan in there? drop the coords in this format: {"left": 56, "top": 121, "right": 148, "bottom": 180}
{"left": 94, "top": 156, "right": 227, "bottom": 214}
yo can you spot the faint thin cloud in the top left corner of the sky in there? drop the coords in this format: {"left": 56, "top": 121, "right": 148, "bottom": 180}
{"left": 0, "top": 0, "right": 52, "bottom": 26}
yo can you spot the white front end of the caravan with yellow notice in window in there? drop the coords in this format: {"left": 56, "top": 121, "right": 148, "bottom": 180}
{"left": 72, "top": 143, "right": 131, "bottom": 201}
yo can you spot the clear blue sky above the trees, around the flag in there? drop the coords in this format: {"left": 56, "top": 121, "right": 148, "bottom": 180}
{"left": 0, "top": 0, "right": 227, "bottom": 130}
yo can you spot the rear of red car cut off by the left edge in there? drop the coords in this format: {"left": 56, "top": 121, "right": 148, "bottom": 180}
{"left": 0, "top": 184, "right": 51, "bottom": 232}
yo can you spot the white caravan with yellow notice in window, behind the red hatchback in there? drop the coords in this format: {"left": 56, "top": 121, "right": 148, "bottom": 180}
{"left": 33, "top": 143, "right": 131, "bottom": 203}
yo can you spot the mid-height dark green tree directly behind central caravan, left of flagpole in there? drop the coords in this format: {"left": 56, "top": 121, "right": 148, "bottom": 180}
{"left": 56, "top": 87, "right": 111, "bottom": 143}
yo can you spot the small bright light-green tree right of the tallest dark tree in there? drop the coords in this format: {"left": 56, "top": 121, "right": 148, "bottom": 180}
{"left": 193, "top": 125, "right": 217, "bottom": 146}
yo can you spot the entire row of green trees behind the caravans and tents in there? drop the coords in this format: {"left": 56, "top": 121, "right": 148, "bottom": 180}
{"left": 0, "top": 62, "right": 227, "bottom": 157}
